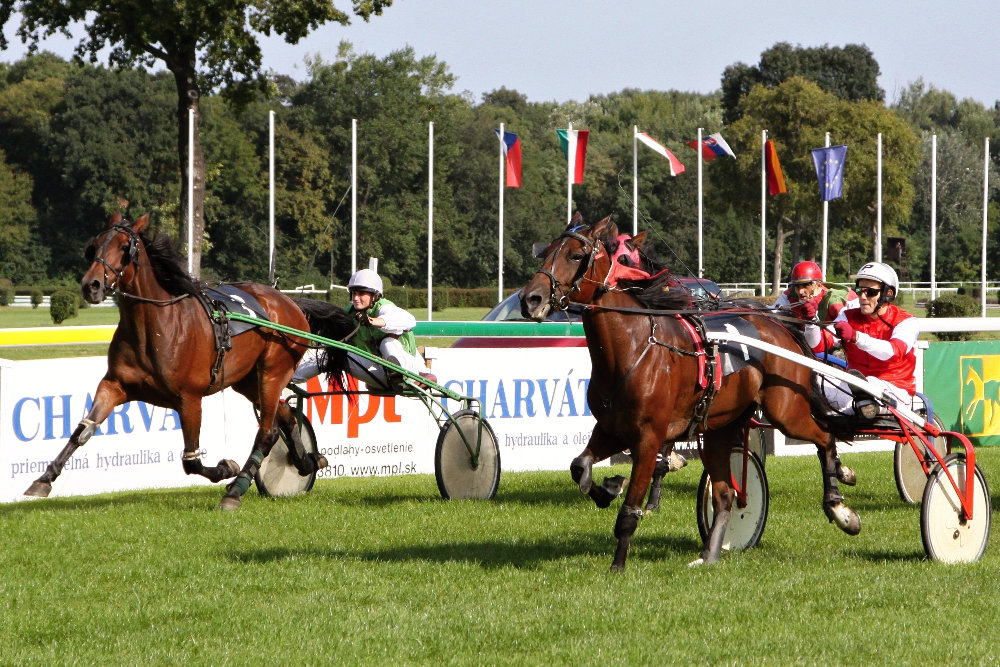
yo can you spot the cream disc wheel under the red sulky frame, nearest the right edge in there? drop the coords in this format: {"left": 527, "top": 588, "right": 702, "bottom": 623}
{"left": 920, "top": 452, "right": 991, "bottom": 563}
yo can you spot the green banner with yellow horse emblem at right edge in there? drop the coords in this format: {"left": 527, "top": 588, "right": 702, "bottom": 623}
{"left": 924, "top": 341, "right": 1000, "bottom": 446}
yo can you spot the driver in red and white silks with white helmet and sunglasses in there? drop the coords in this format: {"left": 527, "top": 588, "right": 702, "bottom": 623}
{"left": 805, "top": 262, "right": 920, "bottom": 414}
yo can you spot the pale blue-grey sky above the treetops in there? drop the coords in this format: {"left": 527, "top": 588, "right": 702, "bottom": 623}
{"left": 0, "top": 0, "right": 1000, "bottom": 106}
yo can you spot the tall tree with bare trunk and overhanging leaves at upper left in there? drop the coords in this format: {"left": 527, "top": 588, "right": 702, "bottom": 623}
{"left": 0, "top": 0, "right": 392, "bottom": 275}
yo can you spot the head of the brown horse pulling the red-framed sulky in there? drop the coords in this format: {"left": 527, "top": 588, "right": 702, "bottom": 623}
{"left": 520, "top": 214, "right": 618, "bottom": 322}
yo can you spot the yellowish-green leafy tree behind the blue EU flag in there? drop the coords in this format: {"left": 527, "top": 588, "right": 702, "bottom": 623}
{"left": 712, "top": 77, "right": 918, "bottom": 290}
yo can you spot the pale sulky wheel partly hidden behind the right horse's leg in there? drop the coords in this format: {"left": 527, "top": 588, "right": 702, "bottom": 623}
{"left": 696, "top": 447, "right": 771, "bottom": 550}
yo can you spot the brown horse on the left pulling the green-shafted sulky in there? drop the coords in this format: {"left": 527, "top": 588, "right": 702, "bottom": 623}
{"left": 25, "top": 214, "right": 353, "bottom": 510}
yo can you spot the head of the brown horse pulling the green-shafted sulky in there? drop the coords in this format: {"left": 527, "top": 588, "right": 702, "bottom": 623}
{"left": 80, "top": 213, "right": 149, "bottom": 303}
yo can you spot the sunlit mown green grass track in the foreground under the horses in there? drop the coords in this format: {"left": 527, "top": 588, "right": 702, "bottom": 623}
{"left": 0, "top": 449, "right": 1000, "bottom": 665}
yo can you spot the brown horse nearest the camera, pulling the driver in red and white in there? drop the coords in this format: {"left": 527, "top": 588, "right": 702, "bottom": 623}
{"left": 520, "top": 217, "right": 861, "bottom": 571}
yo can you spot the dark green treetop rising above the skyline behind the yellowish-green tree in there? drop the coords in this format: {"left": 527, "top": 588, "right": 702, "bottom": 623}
{"left": 722, "top": 42, "right": 885, "bottom": 124}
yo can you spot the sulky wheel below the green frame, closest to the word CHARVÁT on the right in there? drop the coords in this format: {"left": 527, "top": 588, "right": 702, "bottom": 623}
{"left": 434, "top": 410, "right": 500, "bottom": 500}
